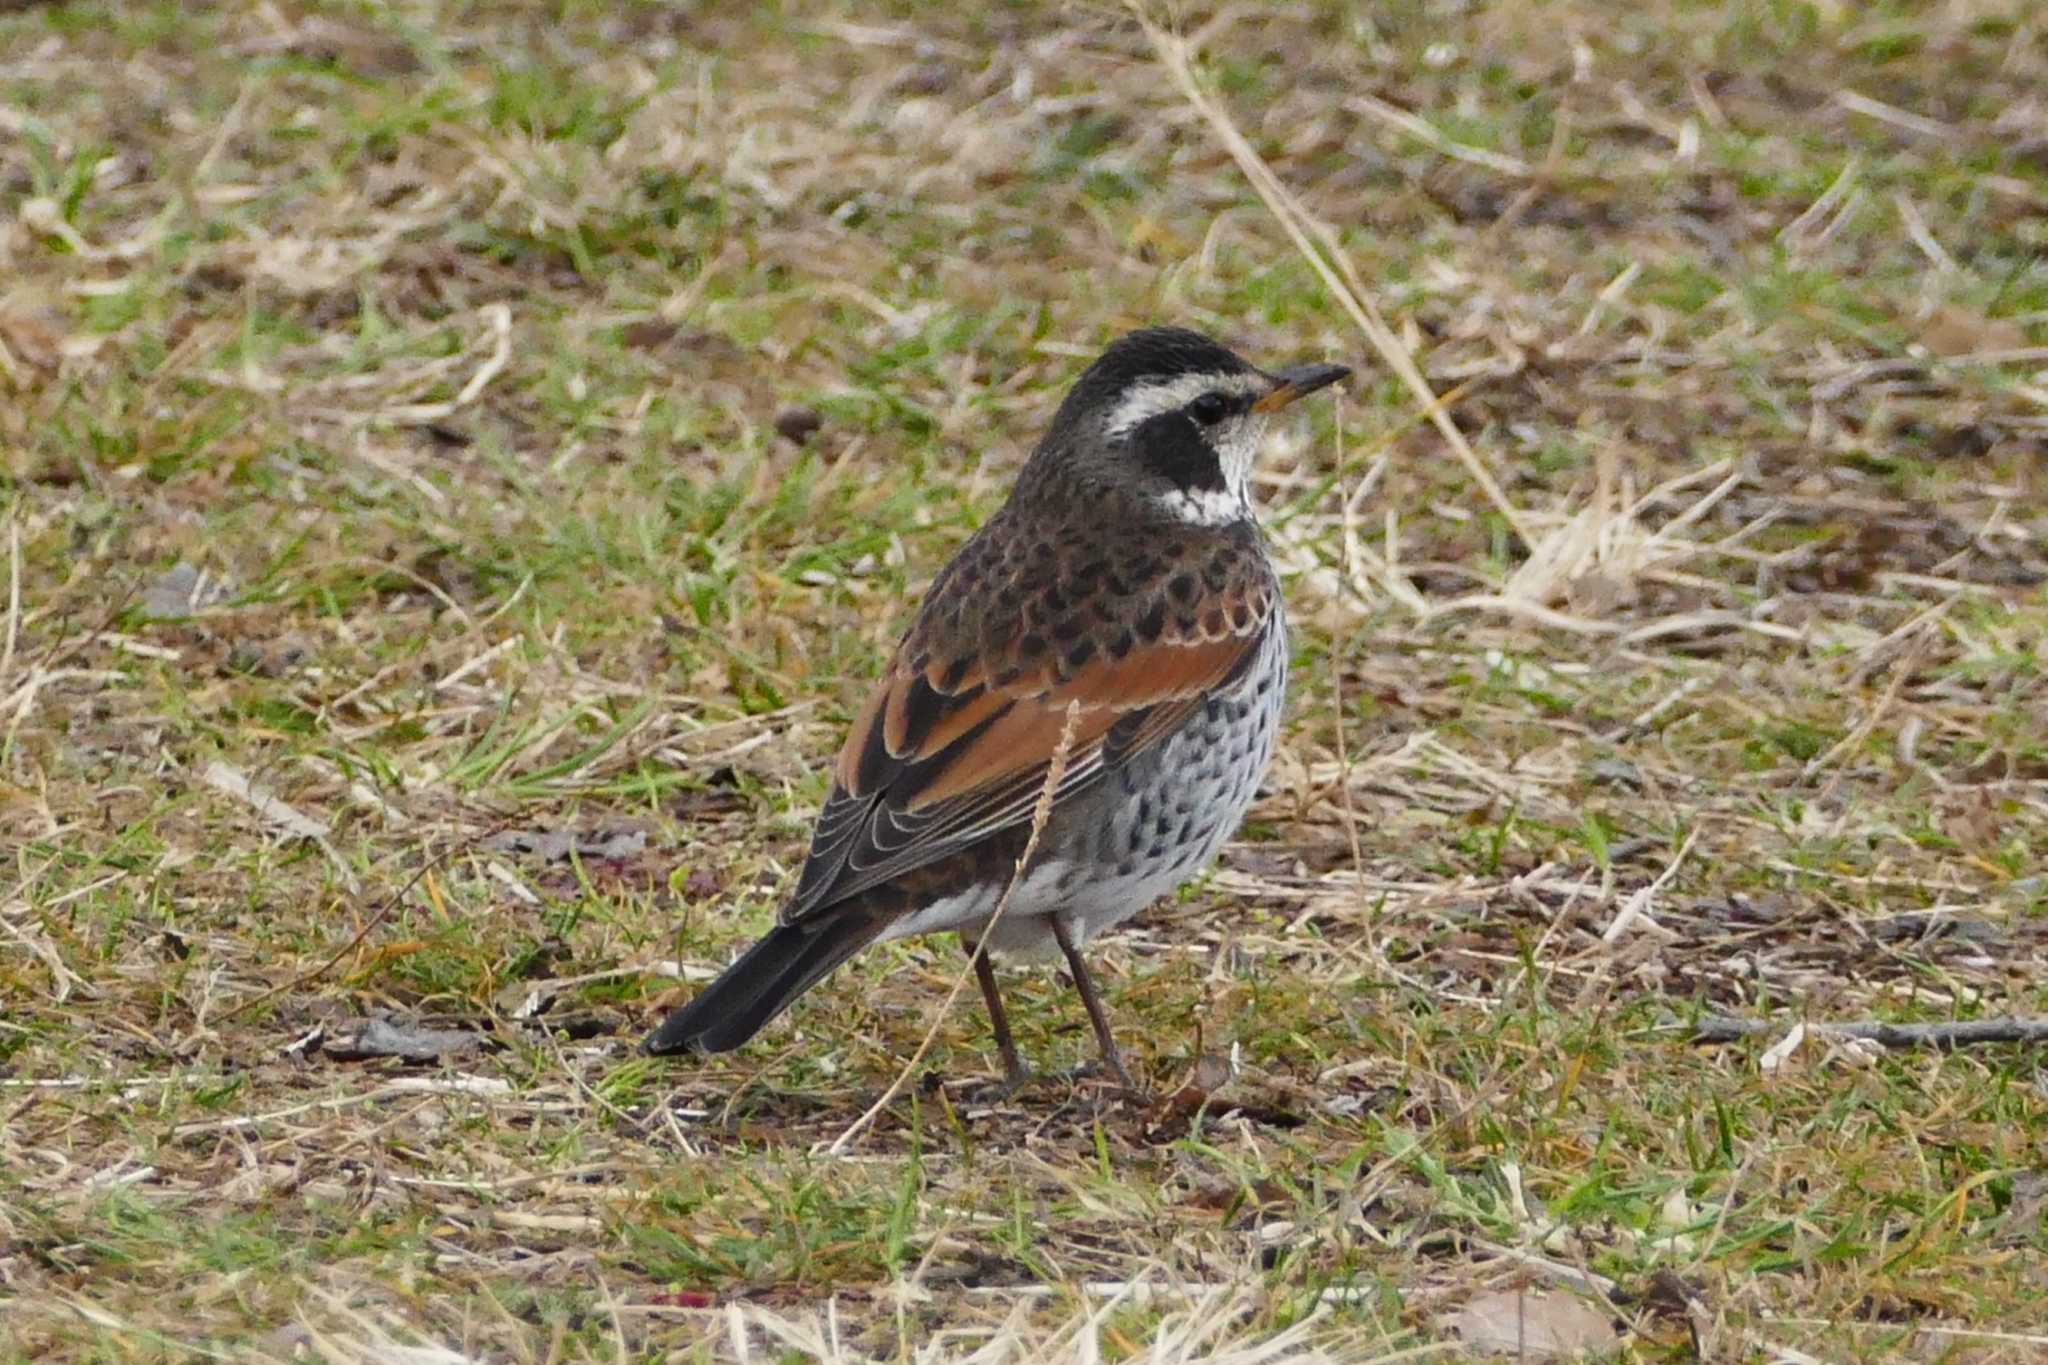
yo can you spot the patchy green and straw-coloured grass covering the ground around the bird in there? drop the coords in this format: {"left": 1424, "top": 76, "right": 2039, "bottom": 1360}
{"left": 0, "top": 0, "right": 2048, "bottom": 1361}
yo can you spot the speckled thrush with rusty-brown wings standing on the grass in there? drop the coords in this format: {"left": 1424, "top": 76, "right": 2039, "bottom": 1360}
{"left": 641, "top": 327, "right": 1350, "bottom": 1093}
